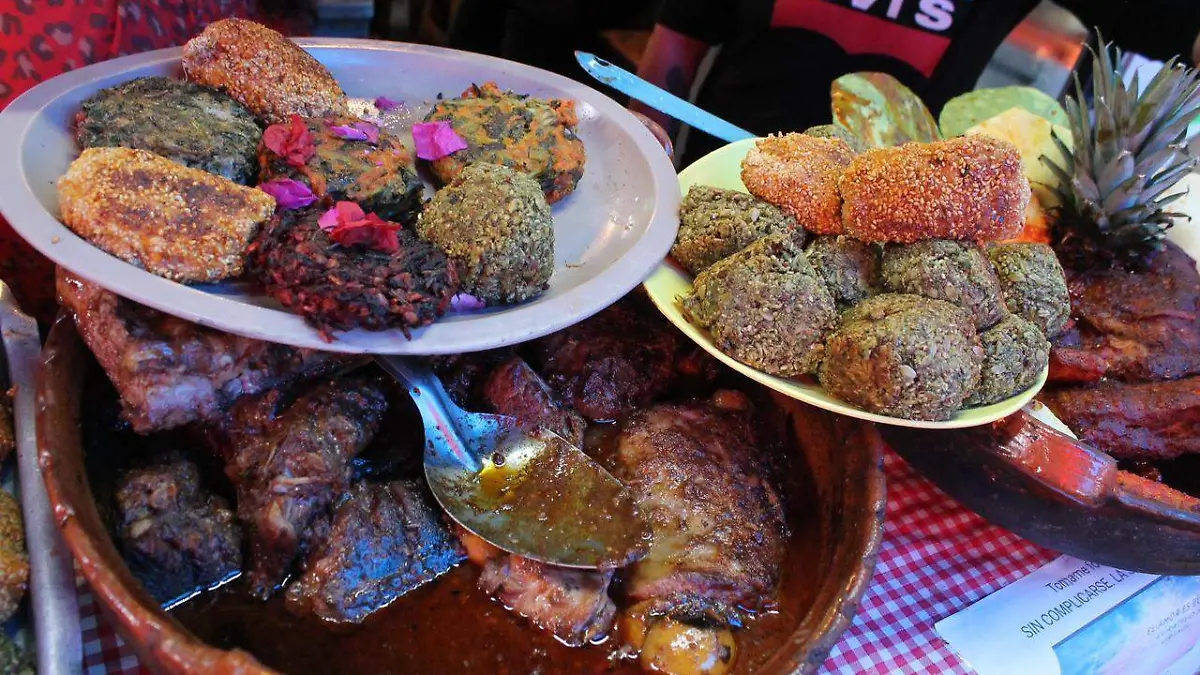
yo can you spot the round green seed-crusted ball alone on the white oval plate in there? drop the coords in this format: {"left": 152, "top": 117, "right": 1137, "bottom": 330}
{"left": 416, "top": 165, "right": 554, "bottom": 304}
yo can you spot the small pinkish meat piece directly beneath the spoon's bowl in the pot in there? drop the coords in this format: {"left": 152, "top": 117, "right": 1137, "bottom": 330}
{"left": 479, "top": 555, "right": 617, "bottom": 646}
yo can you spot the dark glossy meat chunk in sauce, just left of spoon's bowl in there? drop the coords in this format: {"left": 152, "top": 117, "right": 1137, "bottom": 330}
{"left": 287, "top": 482, "right": 464, "bottom": 623}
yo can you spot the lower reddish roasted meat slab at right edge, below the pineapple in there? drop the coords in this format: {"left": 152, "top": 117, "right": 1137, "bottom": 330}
{"left": 1040, "top": 377, "right": 1200, "bottom": 460}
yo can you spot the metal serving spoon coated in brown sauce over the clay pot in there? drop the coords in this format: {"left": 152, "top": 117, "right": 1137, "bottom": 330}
{"left": 376, "top": 356, "right": 649, "bottom": 568}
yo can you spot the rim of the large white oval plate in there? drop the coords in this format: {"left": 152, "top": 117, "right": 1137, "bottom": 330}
{"left": 0, "top": 37, "right": 680, "bottom": 356}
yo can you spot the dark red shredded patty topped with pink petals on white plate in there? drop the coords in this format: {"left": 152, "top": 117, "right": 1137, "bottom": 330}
{"left": 250, "top": 203, "right": 458, "bottom": 340}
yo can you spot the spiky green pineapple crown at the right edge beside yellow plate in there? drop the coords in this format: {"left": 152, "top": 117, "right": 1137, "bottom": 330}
{"left": 1042, "top": 32, "right": 1200, "bottom": 262}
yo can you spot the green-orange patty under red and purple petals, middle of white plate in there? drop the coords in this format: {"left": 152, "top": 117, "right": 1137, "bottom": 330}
{"left": 258, "top": 117, "right": 425, "bottom": 223}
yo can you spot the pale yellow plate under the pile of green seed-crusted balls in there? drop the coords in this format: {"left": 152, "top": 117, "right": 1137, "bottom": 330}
{"left": 646, "top": 139, "right": 1049, "bottom": 429}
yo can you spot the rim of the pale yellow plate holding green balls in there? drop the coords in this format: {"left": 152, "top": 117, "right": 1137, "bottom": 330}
{"left": 642, "top": 138, "right": 1050, "bottom": 430}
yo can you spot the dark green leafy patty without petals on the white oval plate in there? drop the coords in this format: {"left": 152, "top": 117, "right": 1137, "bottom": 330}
{"left": 76, "top": 77, "right": 263, "bottom": 185}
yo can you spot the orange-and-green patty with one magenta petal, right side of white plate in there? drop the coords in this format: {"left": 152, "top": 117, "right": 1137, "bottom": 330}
{"left": 425, "top": 82, "right": 586, "bottom": 203}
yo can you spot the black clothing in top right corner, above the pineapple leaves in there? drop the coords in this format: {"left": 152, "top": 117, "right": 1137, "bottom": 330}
{"left": 1055, "top": 0, "right": 1200, "bottom": 64}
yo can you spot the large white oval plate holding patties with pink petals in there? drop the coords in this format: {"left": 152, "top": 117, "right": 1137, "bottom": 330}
{"left": 0, "top": 38, "right": 679, "bottom": 354}
